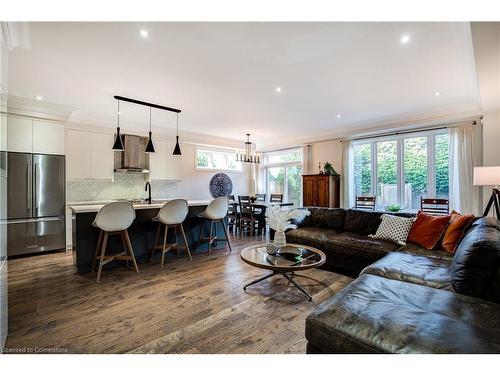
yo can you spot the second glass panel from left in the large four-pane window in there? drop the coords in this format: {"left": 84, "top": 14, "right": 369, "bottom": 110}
{"left": 377, "top": 140, "right": 398, "bottom": 208}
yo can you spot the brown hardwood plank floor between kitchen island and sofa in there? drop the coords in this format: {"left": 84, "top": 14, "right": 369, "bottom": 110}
{"left": 6, "top": 236, "right": 352, "bottom": 353}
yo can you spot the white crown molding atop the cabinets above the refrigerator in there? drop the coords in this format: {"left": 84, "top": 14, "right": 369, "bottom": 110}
{"left": 3, "top": 95, "right": 77, "bottom": 122}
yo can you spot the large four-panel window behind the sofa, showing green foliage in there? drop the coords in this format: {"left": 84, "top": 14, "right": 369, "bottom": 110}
{"left": 353, "top": 130, "right": 450, "bottom": 209}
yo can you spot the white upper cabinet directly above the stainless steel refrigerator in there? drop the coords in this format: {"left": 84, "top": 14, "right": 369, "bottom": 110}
{"left": 7, "top": 116, "right": 65, "bottom": 155}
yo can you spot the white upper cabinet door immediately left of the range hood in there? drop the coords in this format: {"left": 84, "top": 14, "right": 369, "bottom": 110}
{"left": 90, "top": 133, "right": 114, "bottom": 180}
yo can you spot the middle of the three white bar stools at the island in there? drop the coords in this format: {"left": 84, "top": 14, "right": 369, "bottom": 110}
{"left": 151, "top": 199, "right": 193, "bottom": 268}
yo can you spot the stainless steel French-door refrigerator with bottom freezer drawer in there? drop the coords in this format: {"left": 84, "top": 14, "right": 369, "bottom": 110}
{"left": 7, "top": 152, "right": 66, "bottom": 256}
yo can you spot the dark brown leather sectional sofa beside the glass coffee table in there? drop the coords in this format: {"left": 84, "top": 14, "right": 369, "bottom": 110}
{"left": 286, "top": 208, "right": 500, "bottom": 353}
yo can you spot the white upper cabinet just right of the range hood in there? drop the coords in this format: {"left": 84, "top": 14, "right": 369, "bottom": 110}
{"left": 149, "top": 139, "right": 181, "bottom": 181}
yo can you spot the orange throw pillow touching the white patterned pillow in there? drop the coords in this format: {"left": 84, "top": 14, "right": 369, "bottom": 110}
{"left": 408, "top": 211, "right": 451, "bottom": 250}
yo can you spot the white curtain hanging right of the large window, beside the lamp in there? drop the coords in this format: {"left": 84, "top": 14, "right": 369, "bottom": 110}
{"left": 449, "top": 123, "right": 481, "bottom": 215}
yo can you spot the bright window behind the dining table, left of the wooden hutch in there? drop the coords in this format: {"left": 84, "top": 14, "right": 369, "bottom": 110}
{"left": 263, "top": 149, "right": 303, "bottom": 207}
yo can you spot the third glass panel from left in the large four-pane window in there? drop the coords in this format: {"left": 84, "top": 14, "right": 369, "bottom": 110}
{"left": 403, "top": 137, "right": 428, "bottom": 209}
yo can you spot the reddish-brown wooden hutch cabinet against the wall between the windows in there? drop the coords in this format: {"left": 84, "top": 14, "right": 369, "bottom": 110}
{"left": 302, "top": 174, "right": 340, "bottom": 208}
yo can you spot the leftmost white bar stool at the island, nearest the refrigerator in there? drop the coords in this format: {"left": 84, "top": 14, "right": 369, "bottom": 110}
{"left": 92, "top": 202, "right": 139, "bottom": 282}
